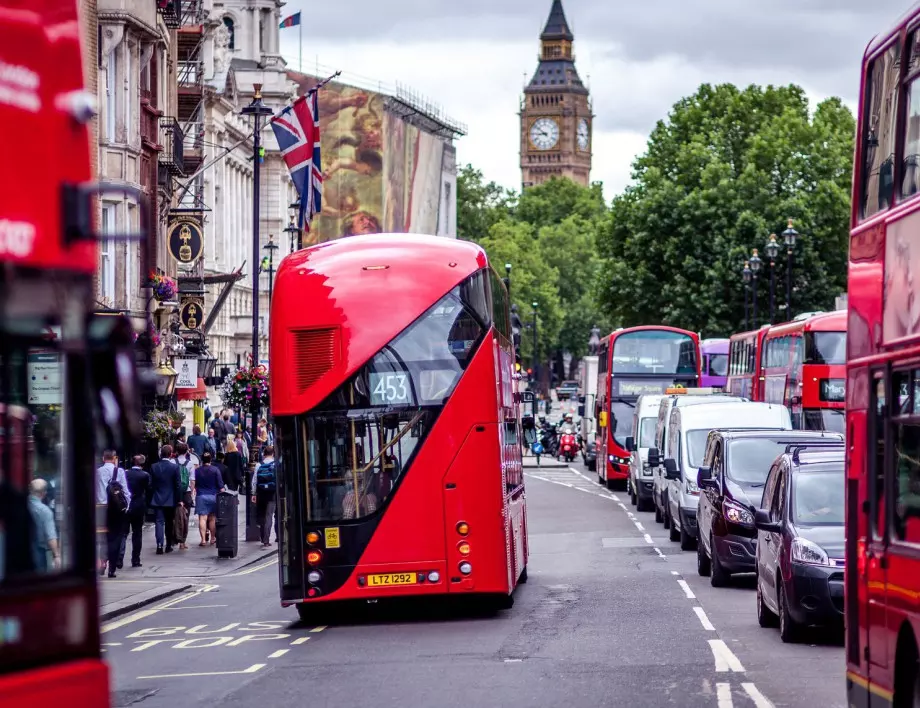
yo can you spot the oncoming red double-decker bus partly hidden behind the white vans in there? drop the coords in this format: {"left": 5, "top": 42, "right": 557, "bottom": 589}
{"left": 595, "top": 325, "right": 700, "bottom": 487}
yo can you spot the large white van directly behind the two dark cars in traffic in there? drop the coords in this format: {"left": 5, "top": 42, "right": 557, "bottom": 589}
{"left": 662, "top": 401, "right": 792, "bottom": 551}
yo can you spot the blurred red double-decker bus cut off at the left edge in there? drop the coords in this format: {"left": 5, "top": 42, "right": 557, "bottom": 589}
{"left": 0, "top": 0, "right": 146, "bottom": 708}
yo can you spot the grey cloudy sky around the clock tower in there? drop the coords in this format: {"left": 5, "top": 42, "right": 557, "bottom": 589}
{"left": 281, "top": 0, "right": 911, "bottom": 198}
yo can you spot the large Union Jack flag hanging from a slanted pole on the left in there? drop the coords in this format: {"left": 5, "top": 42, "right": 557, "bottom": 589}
{"left": 271, "top": 91, "right": 323, "bottom": 229}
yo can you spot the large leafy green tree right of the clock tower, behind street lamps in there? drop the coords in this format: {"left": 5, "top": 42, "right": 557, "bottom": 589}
{"left": 599, "top": 84, "right": 855, "bottom": 336}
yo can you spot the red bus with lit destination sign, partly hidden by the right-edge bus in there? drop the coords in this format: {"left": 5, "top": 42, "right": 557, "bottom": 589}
{"left": 755, "top": 310, "right": 847, "bottom": 433}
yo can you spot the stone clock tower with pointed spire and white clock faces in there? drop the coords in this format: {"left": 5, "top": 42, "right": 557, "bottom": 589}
{"left": 520, "top": 0, "right": 594, "bottom": 187}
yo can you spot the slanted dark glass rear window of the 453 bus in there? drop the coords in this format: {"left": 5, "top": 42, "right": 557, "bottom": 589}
{"left": 278, "top": 288, "right": 485, "bottom": 522}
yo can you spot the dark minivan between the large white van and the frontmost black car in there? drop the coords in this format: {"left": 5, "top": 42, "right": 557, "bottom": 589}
{"left": 696, "top": 430, "right": 843, "bottom": 587}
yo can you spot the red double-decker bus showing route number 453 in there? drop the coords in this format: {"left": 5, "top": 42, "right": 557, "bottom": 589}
{"left": 270, "top": 235, "right": 528, "bottom": 617}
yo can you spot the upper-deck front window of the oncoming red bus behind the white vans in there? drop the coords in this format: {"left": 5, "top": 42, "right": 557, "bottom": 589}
{"left": 612, "top": 330, "right": 697, "bottom": 375}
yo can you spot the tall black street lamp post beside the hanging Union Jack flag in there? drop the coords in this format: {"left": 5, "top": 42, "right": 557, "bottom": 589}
{"left": 241, "top": 84, "right": 273, "bottom": 541}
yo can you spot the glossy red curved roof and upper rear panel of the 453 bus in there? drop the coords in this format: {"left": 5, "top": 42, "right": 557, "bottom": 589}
{"left": 269, "top": 234, "right": 488, "bottom": 414}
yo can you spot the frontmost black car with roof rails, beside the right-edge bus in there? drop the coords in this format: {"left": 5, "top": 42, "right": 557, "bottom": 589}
{"left": 754, "top": 447, "right": 846, "bottom": 642}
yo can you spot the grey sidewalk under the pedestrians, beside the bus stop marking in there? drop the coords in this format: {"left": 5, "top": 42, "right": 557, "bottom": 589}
{"left": 99, "top": 496, "right": 278, "bottom": 620}
